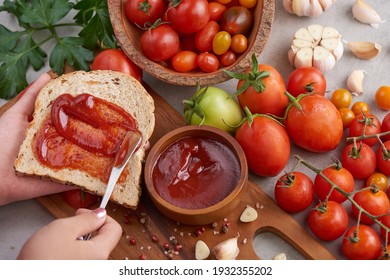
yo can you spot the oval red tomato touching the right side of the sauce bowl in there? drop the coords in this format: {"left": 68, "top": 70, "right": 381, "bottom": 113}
{"left": 235, "top": 111, "right": 290, "bottom": 176}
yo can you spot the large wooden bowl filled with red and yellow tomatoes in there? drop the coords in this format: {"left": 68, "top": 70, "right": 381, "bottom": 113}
{"left": 108, "top": 0, "right": 275, "bottom": 86}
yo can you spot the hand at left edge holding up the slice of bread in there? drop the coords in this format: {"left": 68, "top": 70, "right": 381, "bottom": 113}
{"left": 0, "top": 74, "right": 72, "bottom": 205}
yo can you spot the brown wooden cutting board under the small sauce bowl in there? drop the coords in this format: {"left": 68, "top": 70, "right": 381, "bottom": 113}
{"left": 0, "top": 84, "right": 335, "bottom": 260}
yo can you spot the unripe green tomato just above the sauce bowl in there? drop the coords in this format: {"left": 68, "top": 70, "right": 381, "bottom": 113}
{"left": 184, "top": 87, "right": 243, "bottom": 133}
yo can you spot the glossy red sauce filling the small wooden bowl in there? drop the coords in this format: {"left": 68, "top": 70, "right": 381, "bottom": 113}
{"left": 153, "top": 136, "right": 240, "bottom": 209}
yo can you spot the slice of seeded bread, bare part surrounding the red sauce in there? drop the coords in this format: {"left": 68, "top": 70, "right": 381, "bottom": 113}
{"left": 14, "top": 70, "right": 155, "bottom": 209}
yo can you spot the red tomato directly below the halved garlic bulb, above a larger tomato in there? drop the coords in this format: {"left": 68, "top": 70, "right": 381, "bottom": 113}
{"left": 286, "top": 66, "right": 326, "bottom": 97}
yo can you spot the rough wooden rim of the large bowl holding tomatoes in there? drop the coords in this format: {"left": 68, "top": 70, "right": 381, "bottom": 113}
{"left": 107, "top": 0, "right": 275, "bottom": 86}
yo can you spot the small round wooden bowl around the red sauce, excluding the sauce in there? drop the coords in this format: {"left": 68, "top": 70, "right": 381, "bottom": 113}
{"left": 144, "top": 125, "right": 248, "bottom": 216}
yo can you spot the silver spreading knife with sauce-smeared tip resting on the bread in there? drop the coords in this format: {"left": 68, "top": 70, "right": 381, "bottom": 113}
{"left": 79, "top": 131, "right": 142, "bottom": 240}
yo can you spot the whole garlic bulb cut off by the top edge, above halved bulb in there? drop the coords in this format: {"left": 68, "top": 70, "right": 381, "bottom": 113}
{"left": 283, "top": 0, "right": 336, "bottom": 17}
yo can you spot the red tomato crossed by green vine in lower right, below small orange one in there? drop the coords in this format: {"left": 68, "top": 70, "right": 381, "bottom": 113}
{"left": 352, "top": 188, "right": 390, "bottom": 225}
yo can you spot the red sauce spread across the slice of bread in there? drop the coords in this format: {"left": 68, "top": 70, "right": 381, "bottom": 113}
{"left": 33, "top": 93, "right": 137, "bottom": 182}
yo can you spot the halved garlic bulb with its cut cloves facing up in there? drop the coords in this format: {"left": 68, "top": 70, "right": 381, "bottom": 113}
{"left": 288, "top": 24, "right": 344, "bottom": 73}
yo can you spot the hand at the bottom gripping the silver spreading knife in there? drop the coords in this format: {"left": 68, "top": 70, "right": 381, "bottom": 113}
{"left": 18, "top": 208, "right": 122, "bottom": 260}
